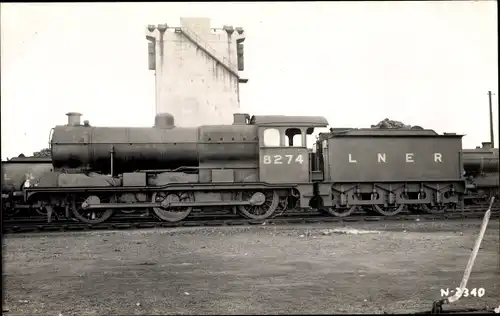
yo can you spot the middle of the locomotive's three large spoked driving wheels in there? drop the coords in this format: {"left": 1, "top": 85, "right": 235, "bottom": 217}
{"left": 153, "top": 192, "right": 194, "bottom": 222}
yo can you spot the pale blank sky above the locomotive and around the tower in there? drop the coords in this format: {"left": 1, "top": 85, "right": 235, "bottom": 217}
{"left": 1, "top": 1, "right": 498, "bottom": 159}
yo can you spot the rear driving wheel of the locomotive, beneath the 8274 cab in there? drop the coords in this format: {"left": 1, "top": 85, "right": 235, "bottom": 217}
{"left": 238, "top": 190, "right": 280, "bottom": 220}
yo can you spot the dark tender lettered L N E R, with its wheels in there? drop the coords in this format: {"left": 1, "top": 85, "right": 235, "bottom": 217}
{"left": 316, "top": 129, "right": 465, "bottom": 216}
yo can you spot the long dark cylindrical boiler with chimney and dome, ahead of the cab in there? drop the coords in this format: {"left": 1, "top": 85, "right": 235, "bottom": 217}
{"left": 51, "top": 113, "right": 257, "bottom": 175}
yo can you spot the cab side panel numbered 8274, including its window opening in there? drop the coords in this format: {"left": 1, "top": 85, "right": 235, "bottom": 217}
{"left": 259, "top": 127, "right": 310, "bottom": 184}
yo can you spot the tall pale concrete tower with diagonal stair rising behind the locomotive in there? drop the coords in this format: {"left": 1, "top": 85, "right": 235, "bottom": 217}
{"left": 146, "top": 18, "right": 247, "bottom": 127}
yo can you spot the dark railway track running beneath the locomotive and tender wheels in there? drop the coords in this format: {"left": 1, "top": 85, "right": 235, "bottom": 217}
{"left": 2, "top": 208, "right": 500, "bottom": 234}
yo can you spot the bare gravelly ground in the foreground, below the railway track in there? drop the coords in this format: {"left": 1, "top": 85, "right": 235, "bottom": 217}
{"left": 2, "top": 220, "right": 500, "bottom": 315}
